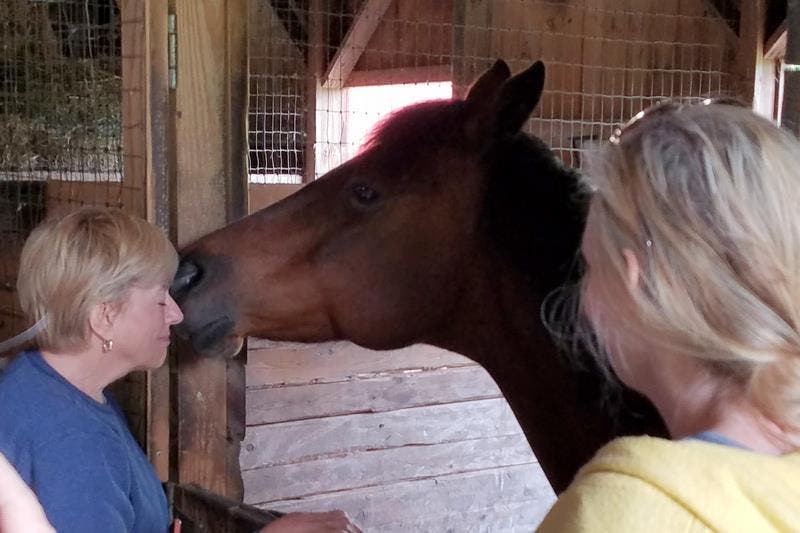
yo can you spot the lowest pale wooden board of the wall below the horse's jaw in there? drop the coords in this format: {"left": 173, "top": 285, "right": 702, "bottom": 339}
{"left": 259, "top": 464, "right": 555, "bottom": 533}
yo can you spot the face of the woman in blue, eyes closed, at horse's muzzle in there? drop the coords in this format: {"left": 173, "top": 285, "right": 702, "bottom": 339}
{"left": 113, "top": 284, "right": 183, "bottom": 369}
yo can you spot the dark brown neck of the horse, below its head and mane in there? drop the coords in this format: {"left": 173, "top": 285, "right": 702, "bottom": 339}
{"left": 435, "top": 256, "right": 614, "bottom": 492}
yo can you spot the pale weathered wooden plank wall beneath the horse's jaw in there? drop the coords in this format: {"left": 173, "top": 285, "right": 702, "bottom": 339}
{"left": 240, "top": 340, "right": 554, "bottom": 532}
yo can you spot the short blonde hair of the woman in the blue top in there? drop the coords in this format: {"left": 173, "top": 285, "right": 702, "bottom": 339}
{"left": 17, "top": 207, "right": 178, "bottom": 351}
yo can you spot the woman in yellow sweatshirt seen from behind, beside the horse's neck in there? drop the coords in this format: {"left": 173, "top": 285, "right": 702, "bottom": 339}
{"left": 542, "top": 102, "right": 800, "bottom": 532}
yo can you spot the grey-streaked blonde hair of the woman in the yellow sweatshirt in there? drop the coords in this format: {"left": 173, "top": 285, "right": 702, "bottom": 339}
{"left": 583, "top": 104, "right": 800, "bottom": 429}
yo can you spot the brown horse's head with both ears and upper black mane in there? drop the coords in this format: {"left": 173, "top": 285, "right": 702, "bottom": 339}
{"left": 172, "top": 61, "right": 580, "bottom": 355}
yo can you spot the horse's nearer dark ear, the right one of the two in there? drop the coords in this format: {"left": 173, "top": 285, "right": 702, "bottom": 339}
{"left": 493, "top": 61, "right": 544, "bottom": 136}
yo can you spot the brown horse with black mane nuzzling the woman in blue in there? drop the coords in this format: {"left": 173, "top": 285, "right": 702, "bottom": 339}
{"left": 172, "top": 61, "right": 664, "bottom": 491}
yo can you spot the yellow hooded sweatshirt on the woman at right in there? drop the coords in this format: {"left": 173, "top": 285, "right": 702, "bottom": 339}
{"left": 538, "top": 437, "right": 800, "bottom": 533}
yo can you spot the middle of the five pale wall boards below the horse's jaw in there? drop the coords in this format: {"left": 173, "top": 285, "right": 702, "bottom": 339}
{"left": 239, "top": 398, "right": 521, "bottom": 470}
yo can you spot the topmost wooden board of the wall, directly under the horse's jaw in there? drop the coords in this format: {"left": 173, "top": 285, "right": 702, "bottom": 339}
{"left": 247, "top": 339, "right": 474, "bottom": 388}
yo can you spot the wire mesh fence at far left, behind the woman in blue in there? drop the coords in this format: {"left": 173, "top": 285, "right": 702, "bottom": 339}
{"left": 0, "top": 0, "right": 143, "bottom": 337}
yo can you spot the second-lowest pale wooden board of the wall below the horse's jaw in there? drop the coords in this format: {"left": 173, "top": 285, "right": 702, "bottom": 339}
{"left": 242, "top": 435, "right": 536, "bottom": 503}
